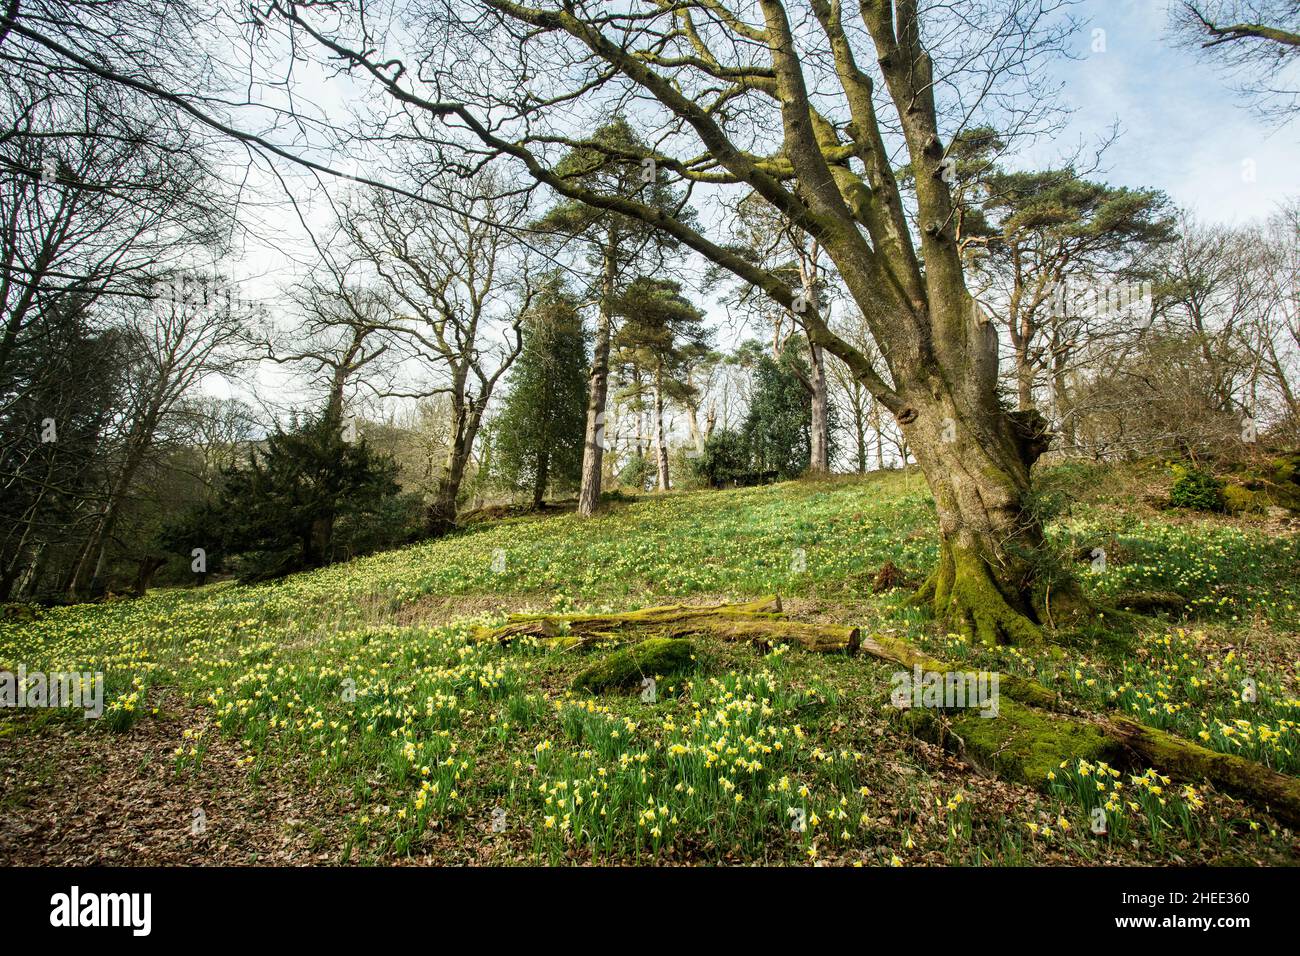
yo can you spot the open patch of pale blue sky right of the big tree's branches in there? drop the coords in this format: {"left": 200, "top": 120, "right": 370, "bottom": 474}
{"left": 1021, "top": 0, "right": 1300, "bottom": 224}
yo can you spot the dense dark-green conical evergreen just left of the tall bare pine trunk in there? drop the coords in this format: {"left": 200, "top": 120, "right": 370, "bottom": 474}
{"left": 494, "top": 280, "right": 588, "bottom": 507}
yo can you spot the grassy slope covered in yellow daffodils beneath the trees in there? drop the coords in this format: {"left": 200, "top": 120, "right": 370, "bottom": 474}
{"left": 0, "top": 467, "right": 1300, "bottom": 865}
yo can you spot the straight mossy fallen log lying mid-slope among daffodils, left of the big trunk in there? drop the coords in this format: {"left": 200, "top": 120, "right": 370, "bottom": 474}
{"left": 473, "top": 596, "right": 861, "bottom": 654}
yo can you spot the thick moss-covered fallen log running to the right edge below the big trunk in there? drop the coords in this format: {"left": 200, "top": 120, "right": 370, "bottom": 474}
{"left": 859, "top": 635, "right": 1300, "bottom": 826}
